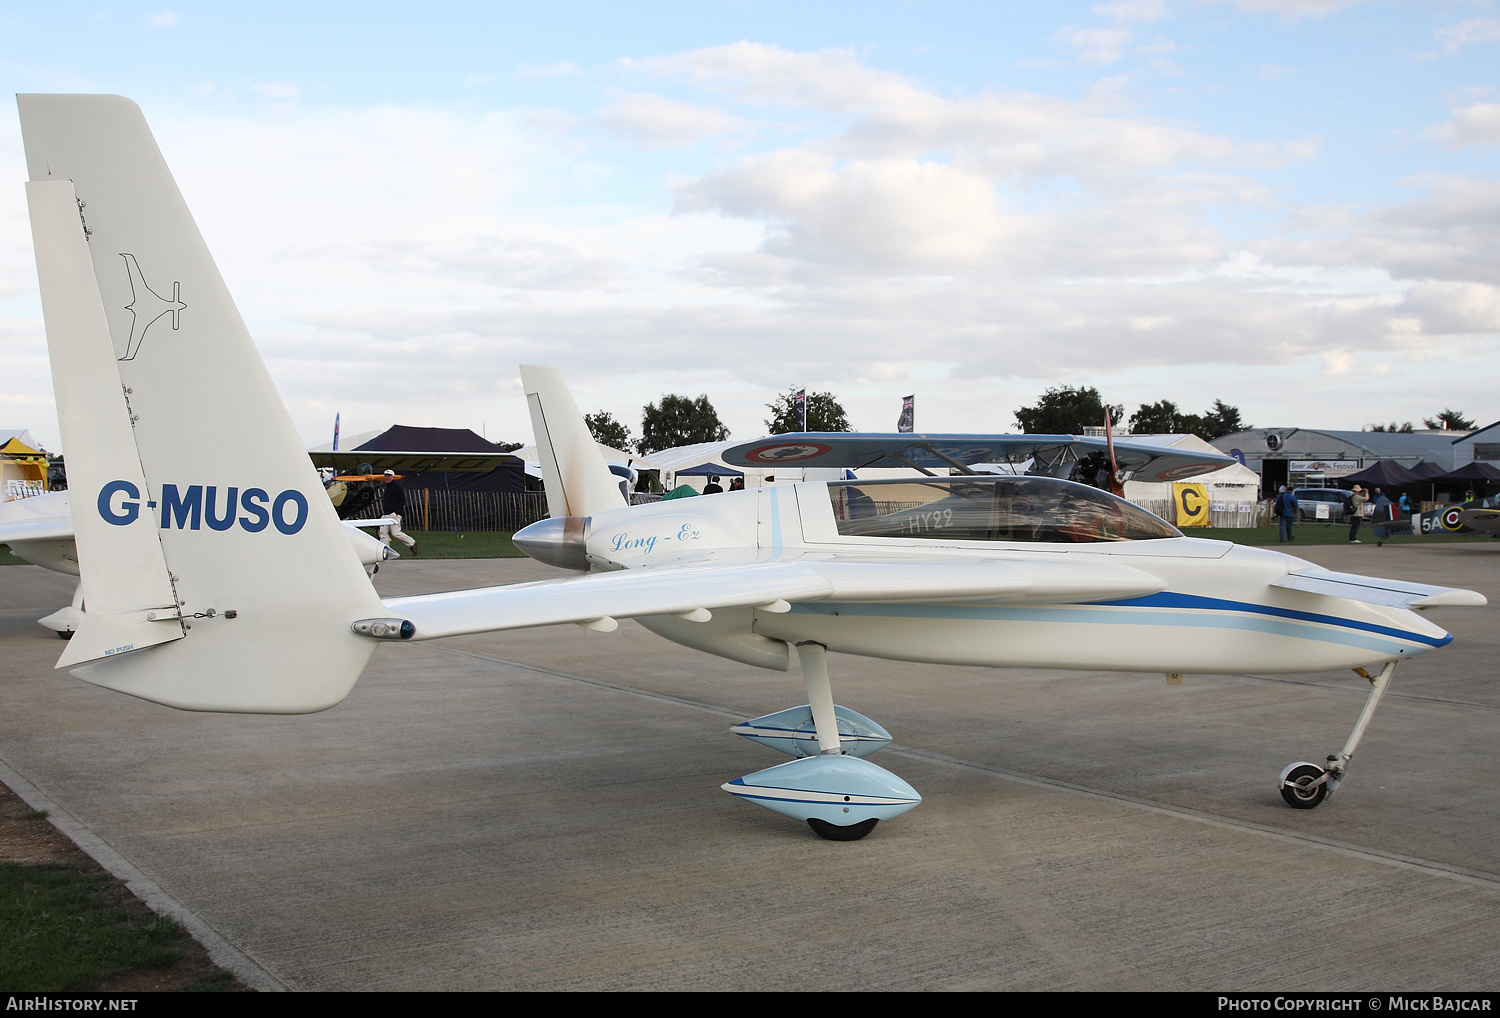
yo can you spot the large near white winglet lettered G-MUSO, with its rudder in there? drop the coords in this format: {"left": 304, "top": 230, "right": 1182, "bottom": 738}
{"left": 17, "top": 94, "right": 383, "bottom": 714}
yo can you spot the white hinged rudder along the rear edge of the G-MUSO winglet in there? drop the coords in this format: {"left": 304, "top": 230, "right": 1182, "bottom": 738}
{"left": 26, "top": 180, "right": 185, "bottom": 669}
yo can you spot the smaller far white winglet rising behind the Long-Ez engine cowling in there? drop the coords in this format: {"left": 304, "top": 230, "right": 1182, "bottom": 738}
{"left": 521, "top": 364, "right": 626, "bottom": 517}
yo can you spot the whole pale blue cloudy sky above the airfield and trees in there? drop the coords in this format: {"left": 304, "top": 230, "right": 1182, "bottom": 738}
{"left": 0, "top": 0, "right": 1500, "bottom": 450}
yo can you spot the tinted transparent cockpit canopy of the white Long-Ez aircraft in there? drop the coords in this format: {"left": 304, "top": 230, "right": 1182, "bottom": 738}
{"left": 828, "top": 475, "right": 1182, "bottom": 544}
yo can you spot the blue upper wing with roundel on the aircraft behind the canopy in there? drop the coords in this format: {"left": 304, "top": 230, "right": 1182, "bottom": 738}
{"left": 723, "top": 432, "right": 1235, "bottom": 481}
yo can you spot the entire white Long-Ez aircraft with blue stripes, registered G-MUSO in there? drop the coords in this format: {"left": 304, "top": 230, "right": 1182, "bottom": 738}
{"left": 11, "top": 96, "right": 1485, "bottom": 840}
